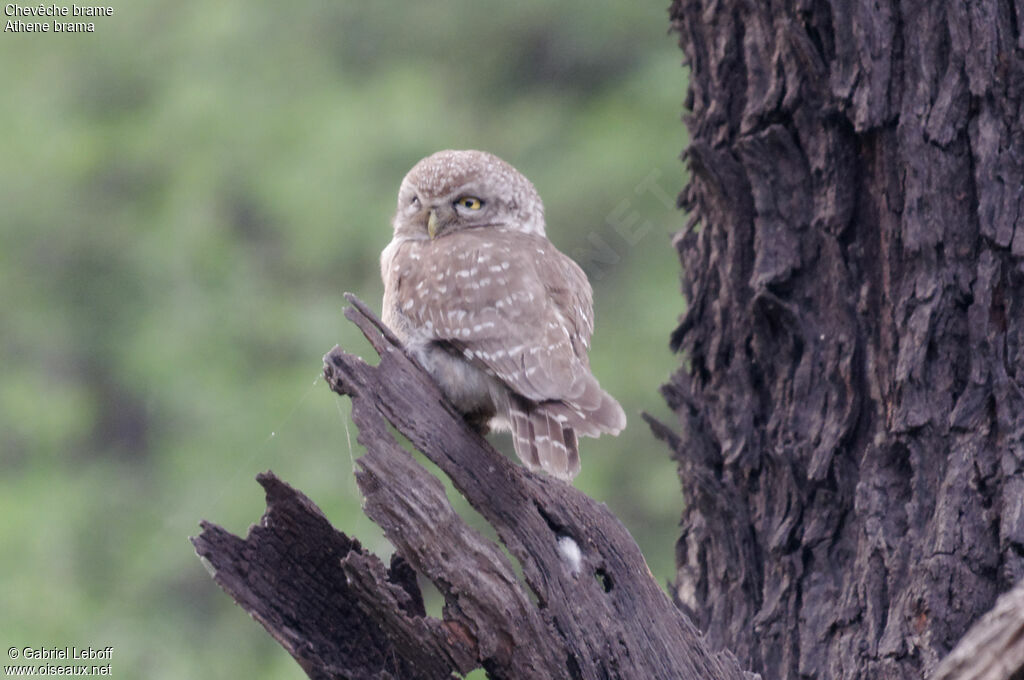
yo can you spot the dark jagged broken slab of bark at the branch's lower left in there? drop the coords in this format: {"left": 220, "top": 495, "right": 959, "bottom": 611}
{"left": 193, "top": 472, "right": 475, "bottom": 680}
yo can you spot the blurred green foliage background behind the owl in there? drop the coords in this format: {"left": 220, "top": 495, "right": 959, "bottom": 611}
{"left": 0, "top": 0, "right": 686, "bottom": 679}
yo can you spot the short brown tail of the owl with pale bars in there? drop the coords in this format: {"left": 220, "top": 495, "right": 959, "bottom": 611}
{"left": 509, "top": 381, "right": 626, "bottom": 481}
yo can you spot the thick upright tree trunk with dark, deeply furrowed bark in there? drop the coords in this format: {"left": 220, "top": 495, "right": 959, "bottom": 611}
{"left": 654, "top": 0, "right": 1024, "bottom": 680}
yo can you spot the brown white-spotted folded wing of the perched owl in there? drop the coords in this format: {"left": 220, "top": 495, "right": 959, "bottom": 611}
{"left": 406, "top": 235, "right": 604, "bottom": 411}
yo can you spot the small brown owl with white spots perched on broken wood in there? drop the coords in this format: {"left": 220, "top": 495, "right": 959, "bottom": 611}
{"left": 381, "top": 151, "right": 626, "bottom": 480}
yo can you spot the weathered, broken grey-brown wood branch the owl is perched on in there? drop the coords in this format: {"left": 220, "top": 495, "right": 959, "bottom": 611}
{"left": 194, "top": 296, "right": 756, "bottom": 680}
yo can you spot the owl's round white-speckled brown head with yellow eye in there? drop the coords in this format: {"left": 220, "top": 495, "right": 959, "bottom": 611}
{"left": 392, "top": 151, "right": 544, "bottom": 239}
